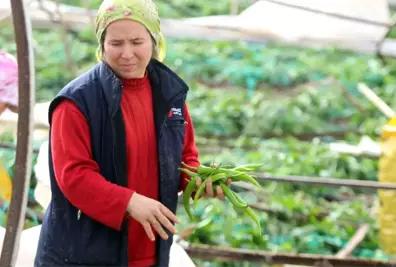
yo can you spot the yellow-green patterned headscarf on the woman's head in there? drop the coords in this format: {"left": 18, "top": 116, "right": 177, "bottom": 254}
{"left": 95, "top": 0, "right": 166, "bottom": 61}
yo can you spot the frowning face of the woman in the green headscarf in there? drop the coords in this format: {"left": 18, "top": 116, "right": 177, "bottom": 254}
{"left": 103, "top": 19, "right": 153, "bottom": 79}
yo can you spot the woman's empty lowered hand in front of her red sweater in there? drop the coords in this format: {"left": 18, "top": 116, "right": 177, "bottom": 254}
{"left": 127, "top": 192, "right": 179, "bottom": 241}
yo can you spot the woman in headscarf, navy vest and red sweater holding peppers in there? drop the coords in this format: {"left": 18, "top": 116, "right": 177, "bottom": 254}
{"left": 35, "top": 0, "right": 229, "bottom": 267}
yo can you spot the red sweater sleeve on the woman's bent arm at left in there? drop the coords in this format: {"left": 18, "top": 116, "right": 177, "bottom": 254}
{"left": 51, "top": 100, "right": 134, "bottom": 230}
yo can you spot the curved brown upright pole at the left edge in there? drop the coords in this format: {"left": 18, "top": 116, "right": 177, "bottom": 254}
{"left": 0, "top": 0, "right": 35, "bottom": 267}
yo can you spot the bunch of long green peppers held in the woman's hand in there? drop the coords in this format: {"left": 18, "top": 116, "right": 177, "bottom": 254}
{"left": 179, "top": 162, "right": 263, "bottom": 233}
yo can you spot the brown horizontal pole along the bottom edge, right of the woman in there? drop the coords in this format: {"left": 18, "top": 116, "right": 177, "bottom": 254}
{"left": 179, "top": 242, "right": 396, "bottom": 267}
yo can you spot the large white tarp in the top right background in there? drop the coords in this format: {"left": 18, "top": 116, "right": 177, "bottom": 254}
{"left": 186, "top": 0, "right": 391, "bottom": 51}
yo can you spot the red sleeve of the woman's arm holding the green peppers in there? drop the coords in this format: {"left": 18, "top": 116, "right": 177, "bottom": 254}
{"left": 180, "top": 104, "right": 200, "bottom": 191}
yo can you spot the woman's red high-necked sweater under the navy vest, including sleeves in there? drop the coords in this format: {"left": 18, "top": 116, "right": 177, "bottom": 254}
{"left": 51, "top": 75, "right": 199, "bottom": 267}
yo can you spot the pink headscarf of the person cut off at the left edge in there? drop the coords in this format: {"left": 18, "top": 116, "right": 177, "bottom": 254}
{"left": 0, "top": 51, "right": 18, "bottom": 106}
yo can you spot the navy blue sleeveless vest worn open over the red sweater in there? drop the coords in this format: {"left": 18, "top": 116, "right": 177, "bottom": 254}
{"left": 34, "top": 60, "right": 188, "bottom": 267}
